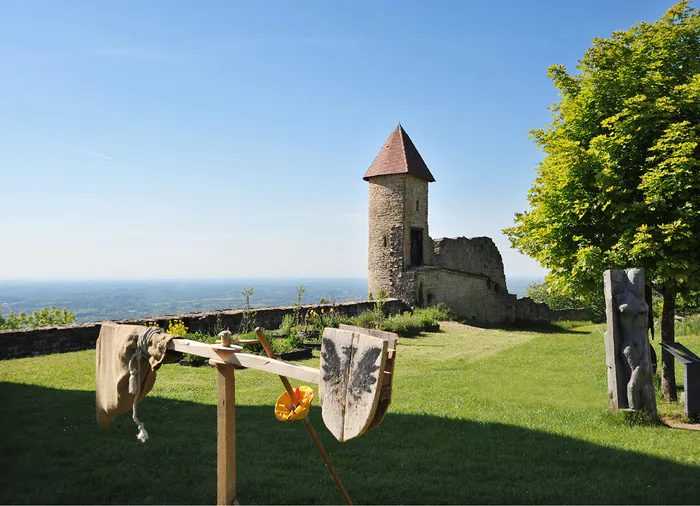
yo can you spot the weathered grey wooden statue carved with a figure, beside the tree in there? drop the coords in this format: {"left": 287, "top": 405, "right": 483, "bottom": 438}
{"left": 604, "top": 269, "right": 658, "bottom": 420}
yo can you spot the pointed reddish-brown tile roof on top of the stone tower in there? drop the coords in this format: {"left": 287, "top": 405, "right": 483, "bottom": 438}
{"left": 362, "top": 123, "right": 435, "bottom": 182}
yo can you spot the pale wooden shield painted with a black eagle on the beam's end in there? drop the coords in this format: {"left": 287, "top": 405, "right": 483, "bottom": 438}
{"left": 319, "top": 328, "right": 388, "bottom": 442}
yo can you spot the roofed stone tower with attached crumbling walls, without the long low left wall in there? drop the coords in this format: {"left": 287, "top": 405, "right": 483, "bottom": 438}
{"left": 363, "top": 124, "right": 582, "bottom": 323}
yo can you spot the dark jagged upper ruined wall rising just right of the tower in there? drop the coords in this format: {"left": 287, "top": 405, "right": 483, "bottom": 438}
{"left": 431, "top": 237, "right": 508, "bottom": 294}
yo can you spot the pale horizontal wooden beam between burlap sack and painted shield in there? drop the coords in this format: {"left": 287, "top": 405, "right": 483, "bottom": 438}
{"left": 168, "top": 339, "right": 320, "bottom": 384}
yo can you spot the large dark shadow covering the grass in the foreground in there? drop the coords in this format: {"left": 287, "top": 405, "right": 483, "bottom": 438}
{"left": 0, "top": 383, "right": 699, "bottom": 504}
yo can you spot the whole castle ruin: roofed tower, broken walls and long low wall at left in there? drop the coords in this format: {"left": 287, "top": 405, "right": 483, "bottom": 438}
{"left": 0, "top": 125, "right": 590, "bottom": 358}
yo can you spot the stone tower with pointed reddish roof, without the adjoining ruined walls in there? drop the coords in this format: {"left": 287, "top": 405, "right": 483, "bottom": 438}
{"left": 363, "top": 124, "right": 435, "bottom": 299}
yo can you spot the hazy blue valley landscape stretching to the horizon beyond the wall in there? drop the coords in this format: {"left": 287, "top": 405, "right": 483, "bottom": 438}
{"left": 0, "top": 277, "right": 535, "bottom": 322}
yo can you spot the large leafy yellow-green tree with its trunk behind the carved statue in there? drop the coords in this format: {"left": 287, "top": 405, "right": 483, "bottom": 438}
{"left": 505, "top": 1, "right": 700, "bottom": 400}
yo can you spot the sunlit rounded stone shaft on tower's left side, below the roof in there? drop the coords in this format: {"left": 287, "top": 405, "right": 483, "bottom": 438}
{"left": 367, "top": 175, "right": 406, "bottom": 297}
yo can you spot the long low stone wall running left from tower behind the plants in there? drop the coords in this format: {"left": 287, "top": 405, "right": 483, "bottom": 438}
{"left": 0, "top": 299, "right": 408, "bottom": 359}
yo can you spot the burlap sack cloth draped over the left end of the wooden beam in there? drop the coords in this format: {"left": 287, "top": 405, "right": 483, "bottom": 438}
{"left": 95, "top": 322, "right": 176, "bottom": 428}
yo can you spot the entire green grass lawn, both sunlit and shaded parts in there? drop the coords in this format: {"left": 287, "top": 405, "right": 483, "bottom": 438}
{"left": 0, "top": 325, "right": 700, "bottom": 504}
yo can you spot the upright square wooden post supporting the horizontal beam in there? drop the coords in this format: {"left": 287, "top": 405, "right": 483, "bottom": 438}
{"left": 216, "top": 365, "right": 236, "bottom": 505}
